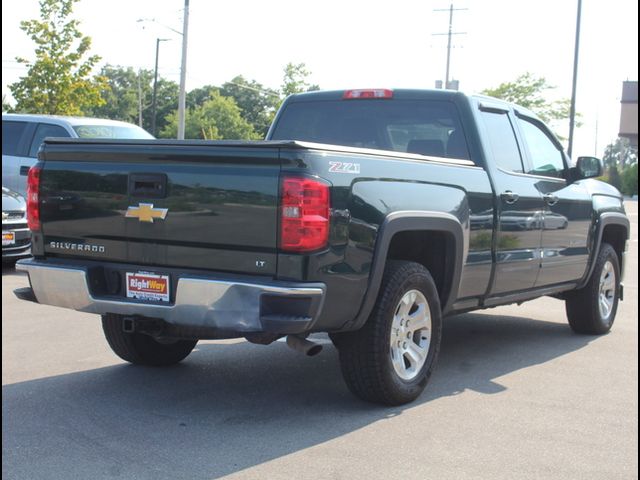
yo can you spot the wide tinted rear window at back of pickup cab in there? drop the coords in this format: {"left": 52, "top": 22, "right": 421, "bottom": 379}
{"left": 271, "top": 99, "right": 469, "bottom": 160}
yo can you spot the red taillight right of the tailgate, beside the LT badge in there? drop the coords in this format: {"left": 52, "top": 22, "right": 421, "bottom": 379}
{"left": 280, "top": 177, "right": 329, "bottom": 252}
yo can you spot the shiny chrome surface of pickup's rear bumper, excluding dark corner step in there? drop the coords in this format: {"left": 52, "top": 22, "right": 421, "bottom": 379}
{"left": 16, "top": 260, "right": 325, "bottom": 331}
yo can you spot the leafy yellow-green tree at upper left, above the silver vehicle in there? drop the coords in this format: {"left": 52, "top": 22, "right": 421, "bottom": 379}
{"left": 9, "top": 0, "right": 106, "bottom": 115}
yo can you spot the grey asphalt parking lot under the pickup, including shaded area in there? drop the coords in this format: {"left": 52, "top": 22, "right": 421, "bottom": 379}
{"left": 2, "top": 202, "right": 638, "bottom": 480}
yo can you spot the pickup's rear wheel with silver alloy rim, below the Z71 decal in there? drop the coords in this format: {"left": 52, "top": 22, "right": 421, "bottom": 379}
{"left": 334, "top": 261, "right": 442, "bottom": 405}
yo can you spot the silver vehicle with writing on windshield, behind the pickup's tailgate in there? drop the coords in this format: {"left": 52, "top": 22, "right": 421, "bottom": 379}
{"left": 2, "top": 113, "right": 153, "bottom": 196}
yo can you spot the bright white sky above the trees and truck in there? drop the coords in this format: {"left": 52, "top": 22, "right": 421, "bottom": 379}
{"left": 2, "top": 0, "right": 638, "bottom": 157}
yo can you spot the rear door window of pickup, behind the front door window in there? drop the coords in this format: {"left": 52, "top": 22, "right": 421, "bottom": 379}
{"left": 481, "top": 112, "right": 524, "bottom": 173}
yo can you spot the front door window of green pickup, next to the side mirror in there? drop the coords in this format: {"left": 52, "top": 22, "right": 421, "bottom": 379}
{"left": 518, "top": 118, "right": 564, "bottom": 178}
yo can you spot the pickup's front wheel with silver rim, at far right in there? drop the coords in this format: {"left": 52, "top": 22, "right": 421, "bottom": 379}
{"left": 565, "top": 243, "right": 620, "bottom": 335}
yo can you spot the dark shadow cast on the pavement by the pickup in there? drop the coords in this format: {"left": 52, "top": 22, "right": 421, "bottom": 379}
{"left": 2, "top": 314, "right": 594, "bottom": 479}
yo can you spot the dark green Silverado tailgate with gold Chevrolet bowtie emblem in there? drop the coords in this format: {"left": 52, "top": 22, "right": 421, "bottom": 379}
{"left": 40, "top": 141, "right": 280, "bottom": 275}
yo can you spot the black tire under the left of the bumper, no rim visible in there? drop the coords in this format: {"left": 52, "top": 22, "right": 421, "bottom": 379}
{"left": 102, "top": 314, "right": 198, "bottom": 367}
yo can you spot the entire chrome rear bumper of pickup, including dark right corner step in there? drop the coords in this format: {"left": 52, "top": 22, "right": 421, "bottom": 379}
{"left": 16, "top": 259, "right": 325, "bottom": 334}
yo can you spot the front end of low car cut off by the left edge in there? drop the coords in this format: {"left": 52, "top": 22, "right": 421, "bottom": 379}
{"left": 2, "top": 187, "right": 31, "bottom": 263}
